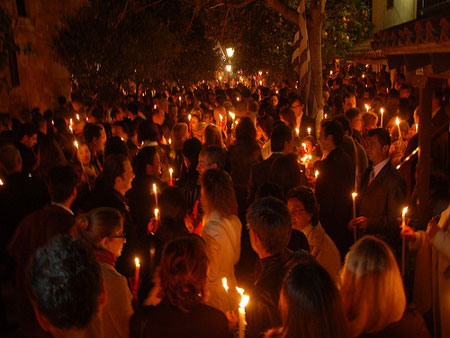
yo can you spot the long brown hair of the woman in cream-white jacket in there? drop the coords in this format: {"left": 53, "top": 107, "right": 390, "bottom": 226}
{"left": 200, "top": 169, "right": 237, "bottom": 218}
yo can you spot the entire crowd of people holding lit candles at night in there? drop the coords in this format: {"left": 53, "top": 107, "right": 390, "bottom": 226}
{"left": 0, "top": 68, "right": 450, "bottom": 338}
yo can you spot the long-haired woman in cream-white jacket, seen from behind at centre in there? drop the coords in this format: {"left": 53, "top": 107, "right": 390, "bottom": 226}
{"left": 200, "top": 169, "right": 242, "bottom": 312}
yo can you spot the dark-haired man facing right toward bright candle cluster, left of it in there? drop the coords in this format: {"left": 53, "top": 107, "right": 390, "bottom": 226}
{"left": 248, "top": 123, "right": 294, "bottom": 203}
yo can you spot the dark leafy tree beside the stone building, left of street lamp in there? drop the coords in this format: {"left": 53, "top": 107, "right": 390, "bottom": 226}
{"left": 53, "top": 0, "right": 217, "bottom": 103}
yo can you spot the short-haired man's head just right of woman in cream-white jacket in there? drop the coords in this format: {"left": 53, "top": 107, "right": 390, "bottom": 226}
{"left": 246, "top": 197, "right": 292, "bottom": 258}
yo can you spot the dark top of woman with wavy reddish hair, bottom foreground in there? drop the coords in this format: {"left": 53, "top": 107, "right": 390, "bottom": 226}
{"left": 130, "top": 300, "right": 229, "bottom": 338}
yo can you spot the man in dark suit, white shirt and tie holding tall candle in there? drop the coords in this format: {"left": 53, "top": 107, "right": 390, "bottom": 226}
{"left": 349, "top": 128, "right": 406, "bottom": 249}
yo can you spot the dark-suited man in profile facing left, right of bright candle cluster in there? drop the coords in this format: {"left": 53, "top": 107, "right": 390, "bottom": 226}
{"left": 316, "top": 120, "right": 355, "bottom": 257}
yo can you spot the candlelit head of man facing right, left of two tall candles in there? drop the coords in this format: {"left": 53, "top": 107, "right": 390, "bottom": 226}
{"left": 102, "top": 154, "right": 134, "bottom": 195}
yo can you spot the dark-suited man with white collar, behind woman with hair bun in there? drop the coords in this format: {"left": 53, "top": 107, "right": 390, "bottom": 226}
{"left": 8, "top": 166, "right": 78, "bottom": 337}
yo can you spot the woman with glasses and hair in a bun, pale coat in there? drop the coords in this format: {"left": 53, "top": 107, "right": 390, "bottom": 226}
{"left": 75, "top": 208, "right": 133, "bottom": 338}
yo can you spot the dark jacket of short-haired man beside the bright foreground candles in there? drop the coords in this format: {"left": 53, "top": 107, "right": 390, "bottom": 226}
{"left": 245, "top": 249, "right": 305, "bottom": 338}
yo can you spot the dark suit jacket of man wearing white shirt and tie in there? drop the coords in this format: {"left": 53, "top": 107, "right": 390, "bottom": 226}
{"left": 358, "top": 162, "right": 406, "bottom": 249}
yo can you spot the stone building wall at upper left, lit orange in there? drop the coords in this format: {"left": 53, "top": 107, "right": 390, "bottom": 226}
{"left": 0, "top": 0, "right": 83, "bottom": 114}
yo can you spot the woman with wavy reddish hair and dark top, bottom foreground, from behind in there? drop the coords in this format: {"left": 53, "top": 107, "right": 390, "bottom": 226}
{"left": 130, "top": 235, "right": 229, "bottom": 338}
